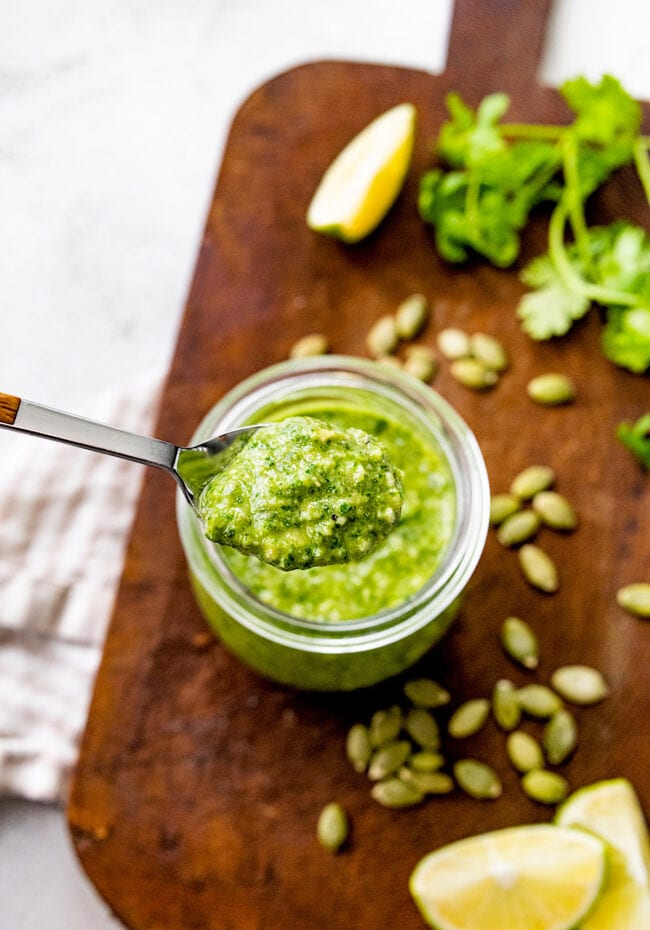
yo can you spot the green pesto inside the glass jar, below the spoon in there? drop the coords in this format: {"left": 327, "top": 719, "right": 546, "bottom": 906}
{"left": 223, "top": 400, "right": 456, "bottom": 621}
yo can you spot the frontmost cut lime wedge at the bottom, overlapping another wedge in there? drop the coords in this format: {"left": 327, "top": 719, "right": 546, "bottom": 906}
{"left": 410, "top": 824, "right": 607, "bottom": 930}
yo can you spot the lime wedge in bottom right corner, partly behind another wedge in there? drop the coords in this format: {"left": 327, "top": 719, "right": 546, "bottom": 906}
{"left": 556, "top": 778, "right": 650, "bottom": 930}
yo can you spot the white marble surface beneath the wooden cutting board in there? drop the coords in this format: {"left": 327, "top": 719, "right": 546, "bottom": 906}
{"left": 0, "top": 0, "right": 650, "bottom": 930}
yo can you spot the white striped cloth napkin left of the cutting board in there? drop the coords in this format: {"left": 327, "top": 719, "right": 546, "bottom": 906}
{"left": 0, "top": 373, "right": 161, "bottom": 803}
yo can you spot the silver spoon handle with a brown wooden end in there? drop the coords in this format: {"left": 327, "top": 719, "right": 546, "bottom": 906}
{"left": 0, "top": 392, "right": 178, "bottom": 477}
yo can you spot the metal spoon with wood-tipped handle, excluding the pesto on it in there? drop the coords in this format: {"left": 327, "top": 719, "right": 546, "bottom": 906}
{"left": 0, "top": 392, "right": 262, "bottom": 510}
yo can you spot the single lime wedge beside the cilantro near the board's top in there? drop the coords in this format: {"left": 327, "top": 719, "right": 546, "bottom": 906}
{"left": 307, "top": 103, "right": 416, "bottom": 242}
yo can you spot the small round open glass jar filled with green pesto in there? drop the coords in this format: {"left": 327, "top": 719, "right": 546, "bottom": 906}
{"left": 177, "top": 356, "right": 489, "bottom": 691}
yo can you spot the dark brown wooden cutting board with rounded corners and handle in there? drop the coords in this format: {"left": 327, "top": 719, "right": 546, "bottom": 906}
{"left": 68, "top": 0, "right": 650, "bottom": 930}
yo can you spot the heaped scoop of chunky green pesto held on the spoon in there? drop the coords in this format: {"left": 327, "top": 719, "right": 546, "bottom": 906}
{"left": 198, "top": 416, "right": 402, "bottom": 571}
